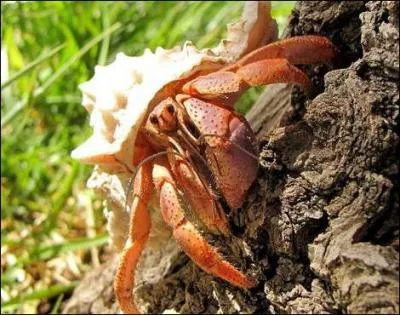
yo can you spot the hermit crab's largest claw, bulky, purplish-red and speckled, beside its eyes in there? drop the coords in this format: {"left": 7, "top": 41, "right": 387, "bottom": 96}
{"left": 183, "top": 98, "right": 258, "bottom": 209}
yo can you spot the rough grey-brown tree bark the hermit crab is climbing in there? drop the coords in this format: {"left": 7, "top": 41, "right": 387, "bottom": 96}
{"left": 64, "top": 1, "right": 399, "bottom": 313}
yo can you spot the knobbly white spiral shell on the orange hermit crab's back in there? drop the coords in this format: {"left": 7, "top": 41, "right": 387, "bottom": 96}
{"left": 71, "top": 2, "right": 276, "bottom": 172}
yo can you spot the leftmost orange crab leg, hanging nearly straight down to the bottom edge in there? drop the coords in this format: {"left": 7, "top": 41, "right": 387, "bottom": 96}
{"left": 114, "top": 163, "right": 153, "bottom": 314}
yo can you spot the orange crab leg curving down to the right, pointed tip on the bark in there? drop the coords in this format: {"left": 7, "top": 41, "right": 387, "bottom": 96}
{"left": 153, "top": 162, "right": 255, "bottom": 288}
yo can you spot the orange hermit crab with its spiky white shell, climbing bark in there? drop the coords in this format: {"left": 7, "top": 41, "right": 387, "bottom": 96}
{"left": 72, "top": 2, "right": 333, "bottom": 313}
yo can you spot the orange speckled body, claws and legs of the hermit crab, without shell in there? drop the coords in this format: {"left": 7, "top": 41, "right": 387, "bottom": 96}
{"left": 115, "top": 36, "right": 334, "bottom": 313}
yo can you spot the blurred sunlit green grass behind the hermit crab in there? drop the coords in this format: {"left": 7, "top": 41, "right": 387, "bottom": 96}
{"left": 1, "top": 1, "right": 294, "bottom": 313}
